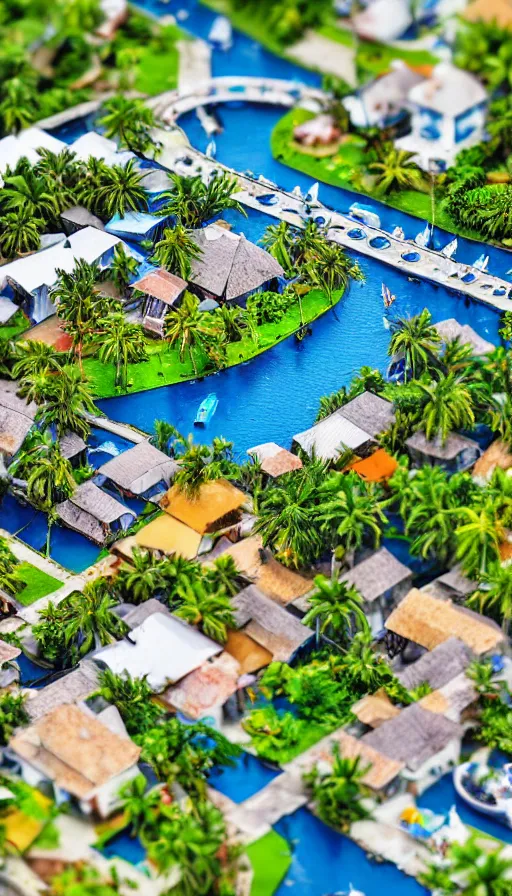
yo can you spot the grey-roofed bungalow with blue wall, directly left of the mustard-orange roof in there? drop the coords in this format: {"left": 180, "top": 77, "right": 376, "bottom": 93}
{"left": 94, "top": 441, "right": 178, "bottom": 503}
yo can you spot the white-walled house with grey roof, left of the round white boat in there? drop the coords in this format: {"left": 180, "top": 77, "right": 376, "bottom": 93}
{"left": 360, "top": 703, "right": 463, "bottom": 795}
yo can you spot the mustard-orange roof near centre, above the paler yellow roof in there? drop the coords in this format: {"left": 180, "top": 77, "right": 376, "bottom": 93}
{"left": 160, "top": 479, "right": 247, "bottom": 535}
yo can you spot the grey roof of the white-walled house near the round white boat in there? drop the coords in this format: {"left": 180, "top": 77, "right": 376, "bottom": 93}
{"left": 361, "top": 703, "right": 463, "bottom": 772}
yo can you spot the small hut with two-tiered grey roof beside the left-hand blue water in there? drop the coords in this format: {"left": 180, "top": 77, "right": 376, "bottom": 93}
{"left": 56, "top": 480, "right": 135, "bottom": 545}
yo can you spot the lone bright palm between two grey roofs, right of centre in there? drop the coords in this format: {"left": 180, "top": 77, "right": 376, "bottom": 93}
{"left": 303, "top": 576, "right": 368, "bottom": 641}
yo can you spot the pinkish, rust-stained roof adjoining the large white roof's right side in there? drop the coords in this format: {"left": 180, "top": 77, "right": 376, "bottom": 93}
{"left": 160, "top": 651, "right": 240, "bottom": 719}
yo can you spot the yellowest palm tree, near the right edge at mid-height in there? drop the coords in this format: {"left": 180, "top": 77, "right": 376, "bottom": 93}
{"left": 455, "top": 499, "right": 504, "bottom": 579}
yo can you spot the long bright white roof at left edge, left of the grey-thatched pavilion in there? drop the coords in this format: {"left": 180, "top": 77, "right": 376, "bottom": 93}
{"left": 0, "top": 227, "right": 121, "bottom": 293}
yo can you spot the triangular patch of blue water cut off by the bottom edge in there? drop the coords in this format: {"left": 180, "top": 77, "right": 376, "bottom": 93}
{"left": 275, "top": 809, "right": 427, "bottom": 896}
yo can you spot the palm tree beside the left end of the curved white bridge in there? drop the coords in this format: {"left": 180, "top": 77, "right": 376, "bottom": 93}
{"left": 98, "top": 95, "right": 159, "bottom": 156}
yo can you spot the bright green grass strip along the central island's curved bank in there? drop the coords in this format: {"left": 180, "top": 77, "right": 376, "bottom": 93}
{"left": 84, "top": 289, "right": 343, "bottom": 398}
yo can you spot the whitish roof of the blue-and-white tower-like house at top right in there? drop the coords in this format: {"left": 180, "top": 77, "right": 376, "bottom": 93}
{"left": 409, "top": 62, "right": 487, "bottom": 118}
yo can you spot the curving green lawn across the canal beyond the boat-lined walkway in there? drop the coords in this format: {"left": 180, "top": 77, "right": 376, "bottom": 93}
{"left": 270, "top": 109, "right": 489, "bottom": 242}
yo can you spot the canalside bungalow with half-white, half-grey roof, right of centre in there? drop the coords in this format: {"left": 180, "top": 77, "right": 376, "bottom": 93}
{"left": 293, "top": 392, "right": 395, "bottom": 461}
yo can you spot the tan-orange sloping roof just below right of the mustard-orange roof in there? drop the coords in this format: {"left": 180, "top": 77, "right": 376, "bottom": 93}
{"left": 221, "top": 535, "right": 313, "bottom": 604}
